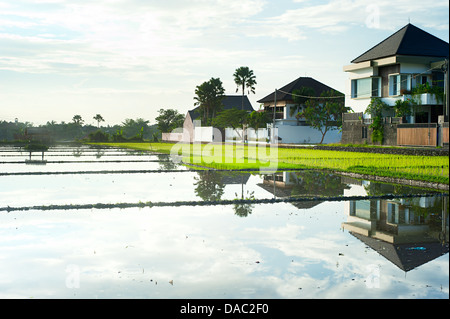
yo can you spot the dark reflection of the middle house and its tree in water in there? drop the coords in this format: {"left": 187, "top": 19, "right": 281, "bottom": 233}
{"left": 258, "top": 170, "right": 347, "bottom": 209}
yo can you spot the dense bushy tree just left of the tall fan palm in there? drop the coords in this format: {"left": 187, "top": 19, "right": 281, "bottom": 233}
{"left": 194, "top": 78, "right": 225, "bottom": 125}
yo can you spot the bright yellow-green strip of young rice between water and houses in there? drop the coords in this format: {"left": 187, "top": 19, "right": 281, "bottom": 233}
{"left": 91, "top": 143, "right": 449, "bottom": 184}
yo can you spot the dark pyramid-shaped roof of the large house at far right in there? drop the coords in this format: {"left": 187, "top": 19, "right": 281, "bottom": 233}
{"left": 352, "top": 24, "right": 449, "bottom": 63}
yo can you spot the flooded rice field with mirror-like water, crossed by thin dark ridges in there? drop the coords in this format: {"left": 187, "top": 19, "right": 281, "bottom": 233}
{"left": 0, "top": 146, "right": 449, "bottom": 299}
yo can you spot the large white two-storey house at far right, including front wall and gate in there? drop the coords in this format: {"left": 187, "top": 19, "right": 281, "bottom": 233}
{"left": 342, "top": 24, "right": 449, "bottom": 146}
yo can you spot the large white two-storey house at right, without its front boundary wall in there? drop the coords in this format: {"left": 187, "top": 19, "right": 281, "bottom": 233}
{"left": 344, "top": 24, "right": 449, "bottom": 123}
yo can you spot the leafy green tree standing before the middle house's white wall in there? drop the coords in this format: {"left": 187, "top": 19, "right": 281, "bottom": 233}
{"left": 299, "top": 90, "right": 350, "bottom": 144}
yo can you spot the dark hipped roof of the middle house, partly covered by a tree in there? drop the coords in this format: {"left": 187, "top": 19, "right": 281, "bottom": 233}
{"left": 257, "top": 77, "right": 337, "bottom": 103}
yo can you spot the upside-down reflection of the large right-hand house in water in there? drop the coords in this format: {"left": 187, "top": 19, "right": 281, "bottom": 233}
{"left": 342, "top": 196, "right": 449, "bottom": 271}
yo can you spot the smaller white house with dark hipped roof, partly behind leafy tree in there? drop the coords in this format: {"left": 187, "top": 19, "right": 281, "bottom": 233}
{"left": 257, "top": 77, "right": 341, "bottom": 144}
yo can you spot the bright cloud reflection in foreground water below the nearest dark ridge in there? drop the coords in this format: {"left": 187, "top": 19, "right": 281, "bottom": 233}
{"left": 0, "top": 203, "right": 448, "bottom": 298}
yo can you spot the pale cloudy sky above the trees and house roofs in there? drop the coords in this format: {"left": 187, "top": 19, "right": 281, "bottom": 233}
{"left": 0, "top": 0, "right": 449, "bottom": 126}
